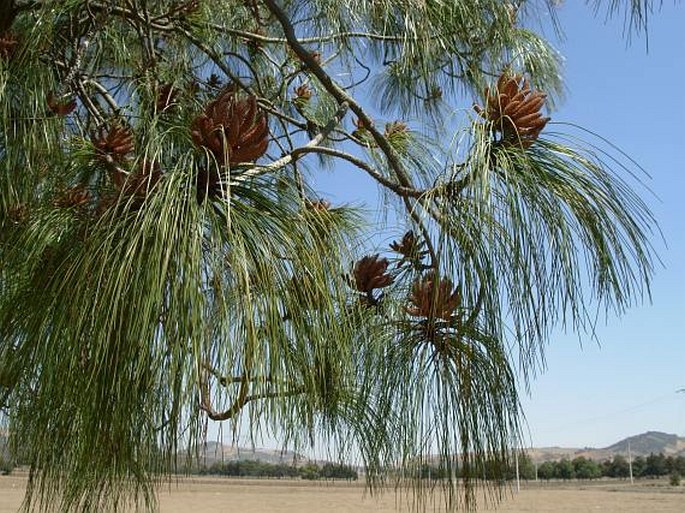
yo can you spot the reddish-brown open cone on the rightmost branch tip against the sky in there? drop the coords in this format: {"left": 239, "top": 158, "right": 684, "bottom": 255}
{"left": 473, "top": 72, "right": 550, "bottom": 148}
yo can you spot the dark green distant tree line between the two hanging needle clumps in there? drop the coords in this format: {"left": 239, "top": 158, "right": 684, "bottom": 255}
{"left": 198, "top": 460, "right": 359, "bottom": 481}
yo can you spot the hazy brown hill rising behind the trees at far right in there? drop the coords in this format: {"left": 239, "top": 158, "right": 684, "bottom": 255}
{"left": 527, "top": 431, "right": 685, "bottom": 463}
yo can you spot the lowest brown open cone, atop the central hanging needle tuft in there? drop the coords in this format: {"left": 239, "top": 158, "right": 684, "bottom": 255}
{"left": 406, "top": 272, "right": 461, "bottom": 321}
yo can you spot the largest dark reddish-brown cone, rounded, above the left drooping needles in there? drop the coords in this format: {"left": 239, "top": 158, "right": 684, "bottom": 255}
{"left": 190, "top": 91, "right": 269, "bottom": 166}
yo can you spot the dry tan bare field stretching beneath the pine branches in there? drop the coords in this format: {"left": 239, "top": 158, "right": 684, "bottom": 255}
{"left": 0, "top": 475, "right": 685, "bottom": 513}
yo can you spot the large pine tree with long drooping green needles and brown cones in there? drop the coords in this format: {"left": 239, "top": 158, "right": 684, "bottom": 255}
{"left": 0, "top": 0, "right": 655, "bottom": 511}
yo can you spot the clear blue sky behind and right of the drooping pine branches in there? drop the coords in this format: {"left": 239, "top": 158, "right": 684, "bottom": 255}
{"left": 312, "top": 0, "right": 685, "bottom": 447}
